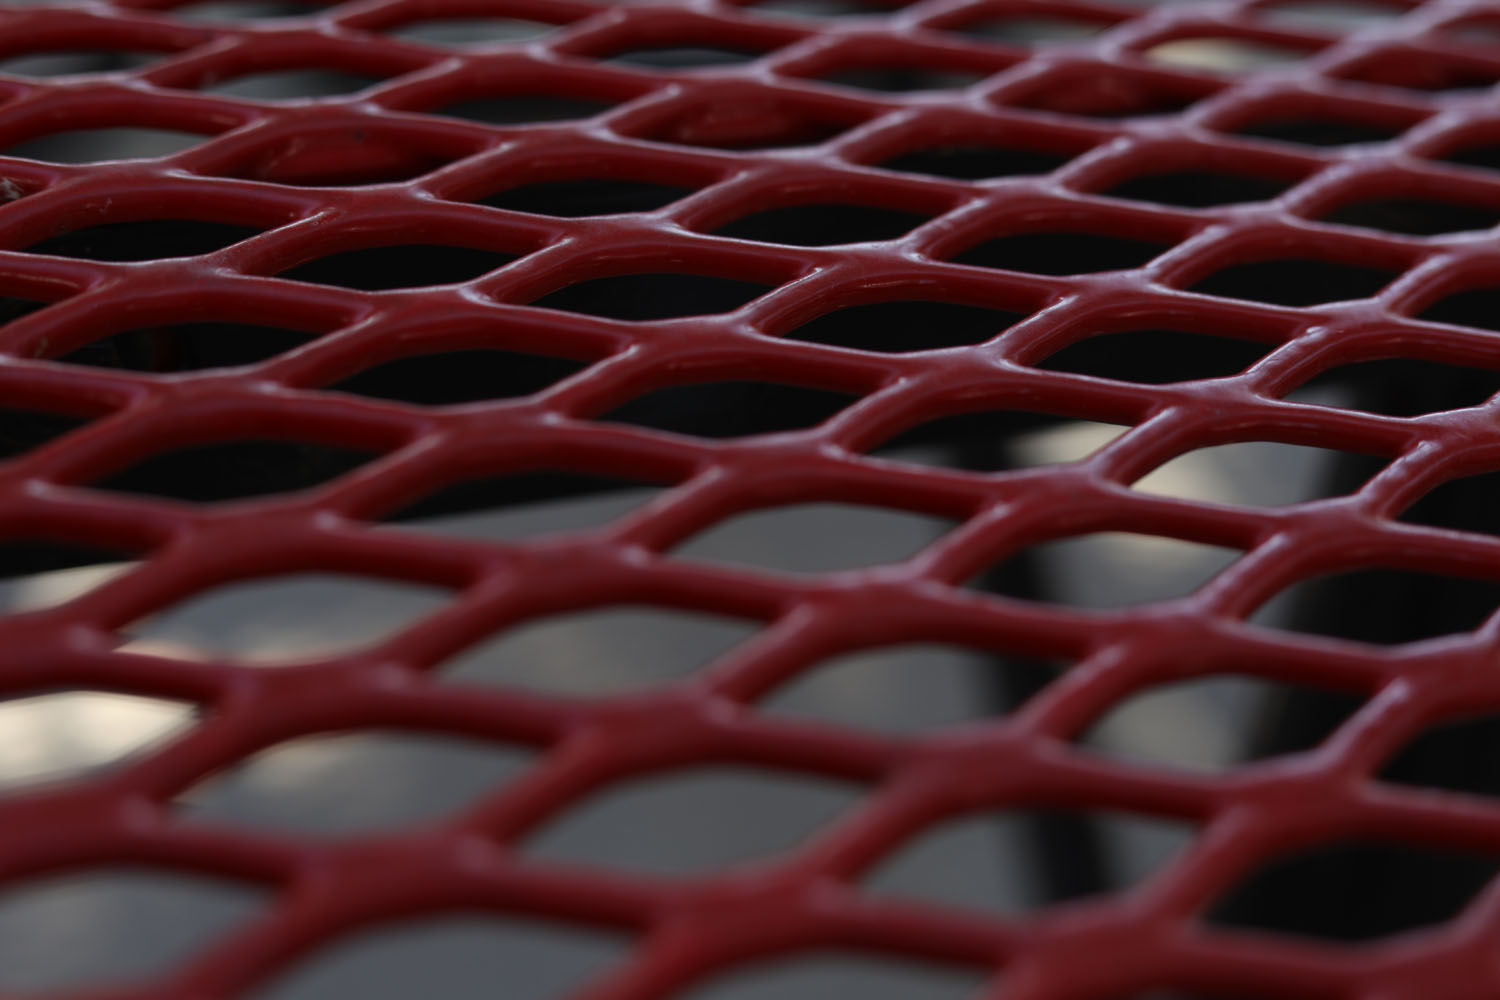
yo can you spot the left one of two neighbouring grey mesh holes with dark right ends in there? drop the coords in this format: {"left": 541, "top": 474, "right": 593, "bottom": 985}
{"left": 759, "top": 643, "right": 1059, "bottom": 736}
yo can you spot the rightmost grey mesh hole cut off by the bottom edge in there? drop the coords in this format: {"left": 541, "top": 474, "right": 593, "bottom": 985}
{"left": 674, "top": 952, "right": 987, "bottom": 1000}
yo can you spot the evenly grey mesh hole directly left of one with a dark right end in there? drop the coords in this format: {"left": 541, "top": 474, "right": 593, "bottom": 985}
{"left": 443, "top": 607, "right": 761, "bottom": 697}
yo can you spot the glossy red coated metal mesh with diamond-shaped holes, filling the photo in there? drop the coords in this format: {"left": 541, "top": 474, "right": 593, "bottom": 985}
{"left": 0, "top": 0, "right": 1500, "bottom": 1000}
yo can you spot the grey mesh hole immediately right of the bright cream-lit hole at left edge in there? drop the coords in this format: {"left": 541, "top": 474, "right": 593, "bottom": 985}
{"left": 177, "top": 730, "right": 531, "bottom": 837}
